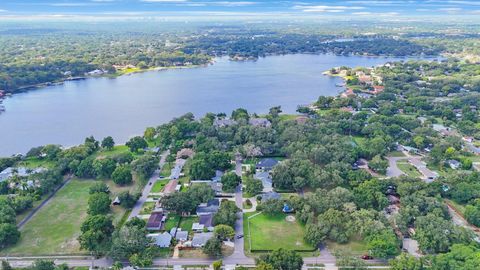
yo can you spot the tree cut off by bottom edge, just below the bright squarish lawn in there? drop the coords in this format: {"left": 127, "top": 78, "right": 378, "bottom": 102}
{"left": 257, "top": 248, "right": 303, "bottom": 270}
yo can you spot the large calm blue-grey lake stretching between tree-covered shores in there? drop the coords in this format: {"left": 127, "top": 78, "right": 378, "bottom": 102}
{"left": 0, "top": 54, "right": 428, "bottom": 156}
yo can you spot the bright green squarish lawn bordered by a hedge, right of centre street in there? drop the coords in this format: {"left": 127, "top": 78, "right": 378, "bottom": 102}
{"left": 245, "top": 214, "right": 313, "bottom": 251}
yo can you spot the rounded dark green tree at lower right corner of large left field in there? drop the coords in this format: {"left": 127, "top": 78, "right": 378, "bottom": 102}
{"left": 78, "top": 215, "right": 114, "bottom": 255}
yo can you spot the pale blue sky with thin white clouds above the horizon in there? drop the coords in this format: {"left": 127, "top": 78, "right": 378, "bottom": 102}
{"left": 0, "top": 0, "right": 480, "bottom": 18}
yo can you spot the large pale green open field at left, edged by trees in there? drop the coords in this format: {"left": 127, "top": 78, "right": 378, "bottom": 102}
{"left": 2, "top": 179, "right": 95, "bottom": 255}
